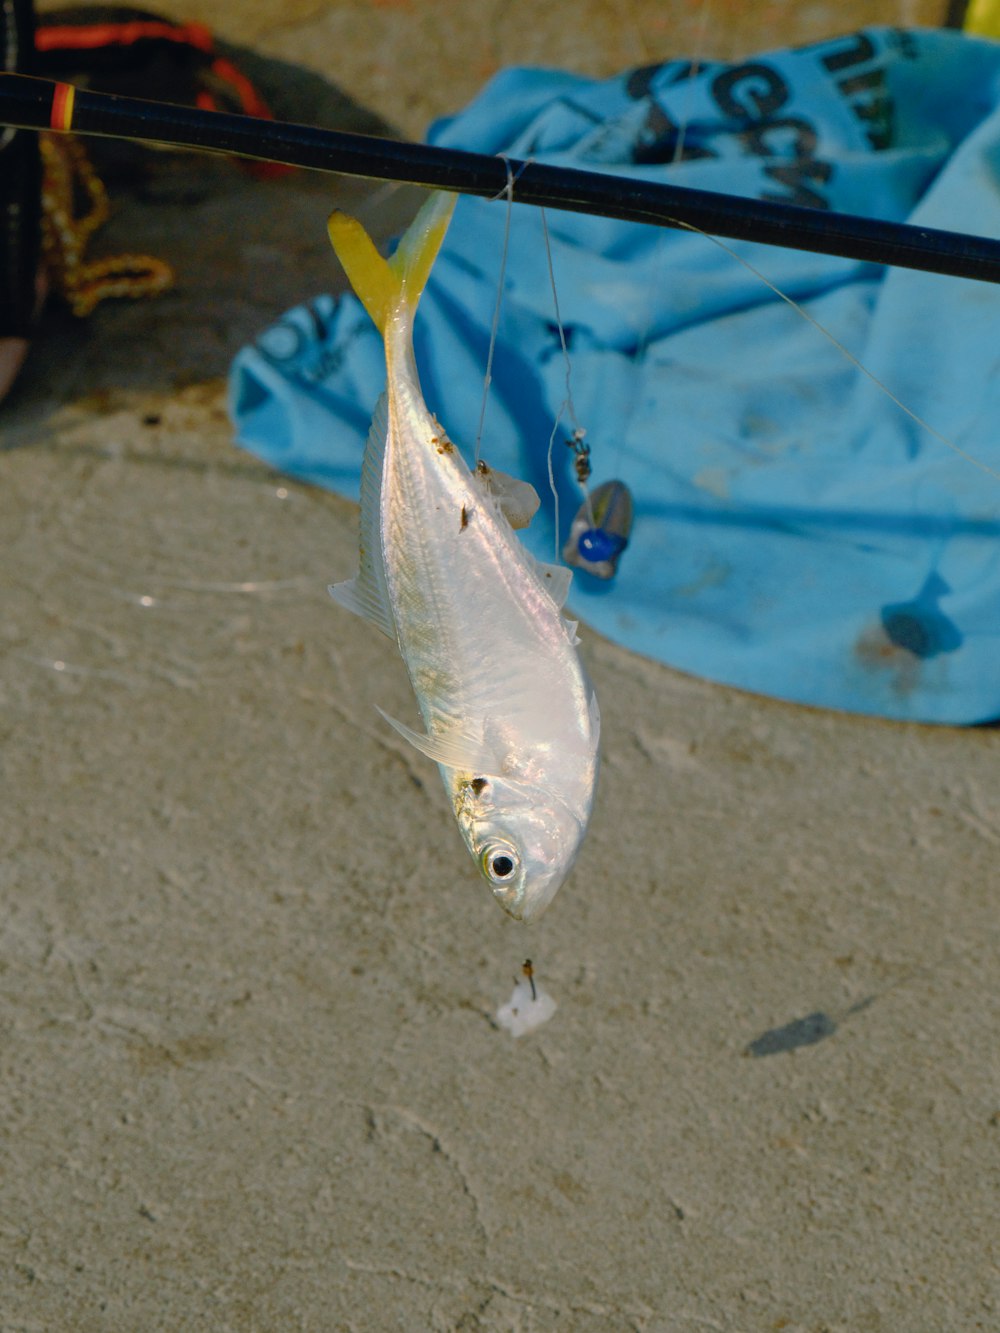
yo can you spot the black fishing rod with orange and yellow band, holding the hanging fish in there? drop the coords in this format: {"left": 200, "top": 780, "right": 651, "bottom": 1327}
{"left": 0, "top": 73, "right": 1000, "bottom": 283}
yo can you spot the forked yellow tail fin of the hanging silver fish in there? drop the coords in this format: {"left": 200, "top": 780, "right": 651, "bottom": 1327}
{"left": 327, "top": 191, "right": 457, "bottom": 333}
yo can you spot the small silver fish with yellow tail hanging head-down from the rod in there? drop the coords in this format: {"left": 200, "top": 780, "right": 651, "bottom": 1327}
{"left": 329, "top": 193, "right": 600, "bottom": 921}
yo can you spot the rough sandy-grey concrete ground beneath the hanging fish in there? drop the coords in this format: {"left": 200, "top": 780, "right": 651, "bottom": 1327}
{"left": 0, "top": 0, "right": 1000, "bottom": 1333}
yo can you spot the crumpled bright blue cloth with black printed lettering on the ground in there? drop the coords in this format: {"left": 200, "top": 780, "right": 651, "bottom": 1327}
{"left": 231, "top": 28, "right": 1000, "bottom": 722}
